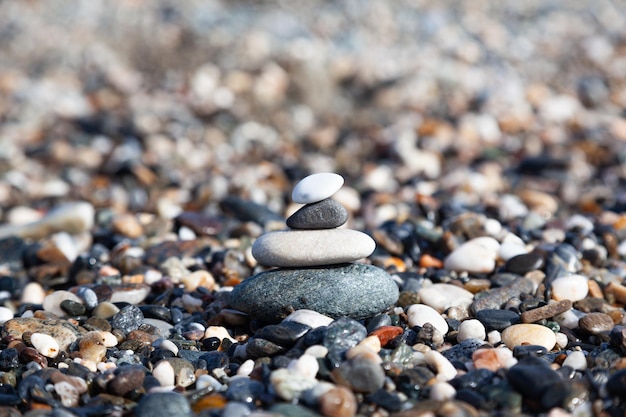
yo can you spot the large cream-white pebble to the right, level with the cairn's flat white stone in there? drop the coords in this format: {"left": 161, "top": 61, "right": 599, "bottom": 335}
{"left": 444, "top": 236, "right": 500, "bottom": 273}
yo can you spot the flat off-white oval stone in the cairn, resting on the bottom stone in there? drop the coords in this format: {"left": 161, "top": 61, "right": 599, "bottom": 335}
{"left": 252, "top": 229, "right": 376, "bottom": 267}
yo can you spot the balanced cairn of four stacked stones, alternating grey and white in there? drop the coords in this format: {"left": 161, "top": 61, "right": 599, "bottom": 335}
{"left": 230, "top": 173, "right": 398, "bottom": 323}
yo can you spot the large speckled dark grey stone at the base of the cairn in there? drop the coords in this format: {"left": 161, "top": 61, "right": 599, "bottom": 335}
{"left": 230, "top": 264, "right": 398, "bottom": 322}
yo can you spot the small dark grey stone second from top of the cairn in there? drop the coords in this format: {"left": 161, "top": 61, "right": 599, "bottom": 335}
{"left": 287, "top": 198, "right": 348, "bottom": 230}
